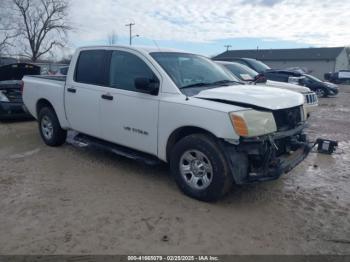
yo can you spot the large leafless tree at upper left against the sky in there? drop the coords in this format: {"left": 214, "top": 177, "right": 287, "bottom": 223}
{"left": 13, "top": 0, "right": 71, "bottom": 62}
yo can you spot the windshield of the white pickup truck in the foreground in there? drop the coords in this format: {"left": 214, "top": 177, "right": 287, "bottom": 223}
{"left": 150, "top": 52, "right": 237, "bottom": 95}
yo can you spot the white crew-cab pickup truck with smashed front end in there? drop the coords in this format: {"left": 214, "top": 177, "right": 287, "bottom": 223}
{"left": 23, "top": 46, "right": 310, "bottom": 201}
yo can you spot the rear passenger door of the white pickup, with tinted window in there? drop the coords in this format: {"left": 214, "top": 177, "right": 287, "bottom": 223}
{"left": 65, "top": 50, "right": 107, "bottom": 137}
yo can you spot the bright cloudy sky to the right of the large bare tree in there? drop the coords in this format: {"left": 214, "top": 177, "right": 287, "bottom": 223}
{"left": 65, "top": 0, "right": 350, "bottom": 55}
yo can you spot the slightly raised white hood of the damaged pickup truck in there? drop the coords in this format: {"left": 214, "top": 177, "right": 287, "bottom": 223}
{"left": 194, "top": 85, "right": 304, "bottom": 110}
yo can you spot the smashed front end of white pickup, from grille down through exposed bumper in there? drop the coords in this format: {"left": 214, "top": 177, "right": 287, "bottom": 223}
{"left": 222, "top": 100, "right": 311, "bottom": 184}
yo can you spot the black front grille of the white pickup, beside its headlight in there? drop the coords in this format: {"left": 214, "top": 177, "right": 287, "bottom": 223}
{"left": 273, "top": 106, "right": 303, "bottom": 131}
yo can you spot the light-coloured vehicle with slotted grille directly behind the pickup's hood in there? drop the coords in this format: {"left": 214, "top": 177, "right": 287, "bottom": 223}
{"left": 216, "top": 61, "right": 318, "bottom": 116}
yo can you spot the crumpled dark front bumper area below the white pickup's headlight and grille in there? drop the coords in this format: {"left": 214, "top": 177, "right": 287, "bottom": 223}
{"left": 221, "top": 127, "right": 312, "bottom": 184}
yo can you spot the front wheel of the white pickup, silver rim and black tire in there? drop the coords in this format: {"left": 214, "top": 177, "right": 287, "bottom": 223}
{"left": 170, "top": 134, "right": 233, "bottom": 202}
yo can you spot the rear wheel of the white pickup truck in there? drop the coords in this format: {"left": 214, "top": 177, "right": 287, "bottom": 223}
{"left": 38, "top": 107, "right": 67, "bottom": 147}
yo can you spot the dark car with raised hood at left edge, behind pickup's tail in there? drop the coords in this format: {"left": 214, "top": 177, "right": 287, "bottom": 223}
{"left": 0, "top": 63, "right": 40, "bottom": 120}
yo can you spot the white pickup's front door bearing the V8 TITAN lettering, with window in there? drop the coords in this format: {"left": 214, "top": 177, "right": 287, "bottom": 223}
{"left": 101, "top": 50, "right": 160, "bottom": 155}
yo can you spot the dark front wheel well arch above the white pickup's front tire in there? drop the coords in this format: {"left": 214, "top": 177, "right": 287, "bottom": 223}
{"left": 166, "top": 126, "right": 216, "bottom": 161}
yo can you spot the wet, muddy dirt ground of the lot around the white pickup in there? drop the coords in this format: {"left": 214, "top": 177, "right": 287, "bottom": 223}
{"left": 0, "top": 86, "right": 350, "bottom": 254}
